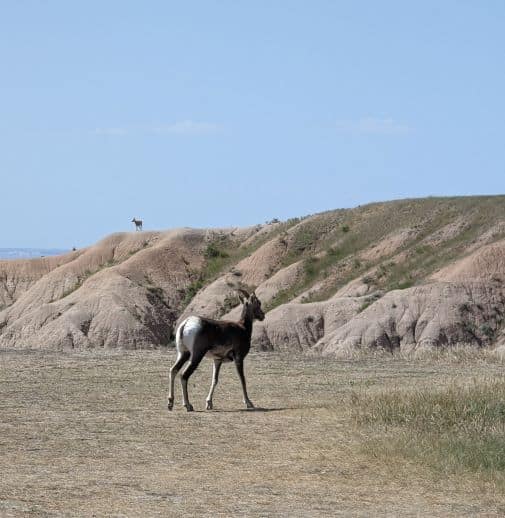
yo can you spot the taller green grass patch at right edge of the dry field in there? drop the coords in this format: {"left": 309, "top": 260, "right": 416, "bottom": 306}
{"left": 351, "top": 381, "right": 505, "bottom": 483}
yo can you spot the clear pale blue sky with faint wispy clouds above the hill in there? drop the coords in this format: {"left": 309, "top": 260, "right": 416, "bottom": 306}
{"left": 0, "top": 0, "right": 505, "bottom": 247}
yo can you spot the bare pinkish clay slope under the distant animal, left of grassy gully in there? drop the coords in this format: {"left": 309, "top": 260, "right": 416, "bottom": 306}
{"left": 0, "top": 229, "right": 264, "bottom": 348}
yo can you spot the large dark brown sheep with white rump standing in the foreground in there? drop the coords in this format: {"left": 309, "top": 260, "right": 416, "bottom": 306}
{"left": 168, "top": 290, "right": 265, "bottom": 412}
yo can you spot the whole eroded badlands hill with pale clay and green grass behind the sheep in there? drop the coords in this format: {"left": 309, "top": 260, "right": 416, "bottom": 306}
{"left": 0, "top": 196, "right": 505, "bottom": 355}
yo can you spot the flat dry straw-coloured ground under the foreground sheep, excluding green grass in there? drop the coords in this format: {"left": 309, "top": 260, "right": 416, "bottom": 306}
{"left": 0, "top": 350, "right": 505, "bottom": 517}
